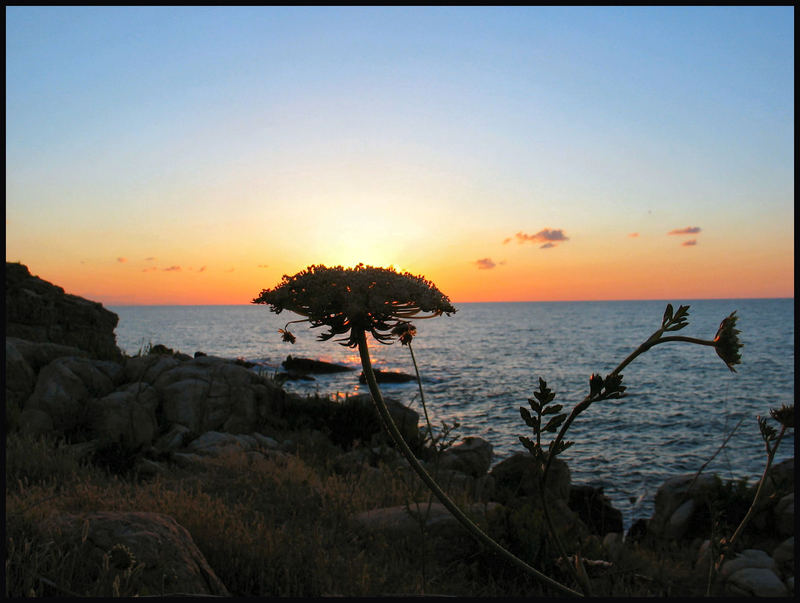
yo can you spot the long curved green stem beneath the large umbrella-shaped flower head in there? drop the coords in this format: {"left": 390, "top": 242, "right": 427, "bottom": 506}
{"left": 357, "top": 331, "right": 582, "bottom": 597}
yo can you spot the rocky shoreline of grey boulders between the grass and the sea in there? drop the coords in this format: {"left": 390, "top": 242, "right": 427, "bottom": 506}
{"left": 5, "top": 263, "right": 794, "bottom": 596}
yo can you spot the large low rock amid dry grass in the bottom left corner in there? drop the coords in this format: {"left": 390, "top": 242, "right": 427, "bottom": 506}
{"left": 44, "top": 511, "right": 230, "bottom": 596}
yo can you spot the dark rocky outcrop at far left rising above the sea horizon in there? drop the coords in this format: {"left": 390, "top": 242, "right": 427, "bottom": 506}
{"left": 6, "top": 262, "right": 122, "bottom": 360}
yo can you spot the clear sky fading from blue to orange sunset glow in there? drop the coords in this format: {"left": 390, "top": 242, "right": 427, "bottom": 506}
{"left": 5, "top": 6, "right": 794, "bottom": 306}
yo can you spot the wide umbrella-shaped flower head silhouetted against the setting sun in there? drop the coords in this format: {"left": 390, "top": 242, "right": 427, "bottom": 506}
{"left": 253, "top": 264, "right": 456, "bottom": 347}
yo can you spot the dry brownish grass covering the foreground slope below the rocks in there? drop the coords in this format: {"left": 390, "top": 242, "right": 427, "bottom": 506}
{"left": 5, "top": 434, "right": 701, "bottom": 597}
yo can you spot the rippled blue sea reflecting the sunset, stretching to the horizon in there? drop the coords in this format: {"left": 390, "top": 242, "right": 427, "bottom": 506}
{"left": 111, "top": 299, "right": 794, "bottom": 527}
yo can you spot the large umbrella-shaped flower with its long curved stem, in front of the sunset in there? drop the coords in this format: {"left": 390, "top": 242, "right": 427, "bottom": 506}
{"left": 253, "top": 264, "right": 580, "bottom": 595}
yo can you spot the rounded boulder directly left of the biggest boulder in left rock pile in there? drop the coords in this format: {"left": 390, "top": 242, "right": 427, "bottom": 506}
{"left": 88, "top": 383, "right": 158, "bottom": 451}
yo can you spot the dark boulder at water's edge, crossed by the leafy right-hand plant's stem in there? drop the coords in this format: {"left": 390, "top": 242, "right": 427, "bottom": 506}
{"left": 490, "top": 452, "right": 570, "bottom": 504}
